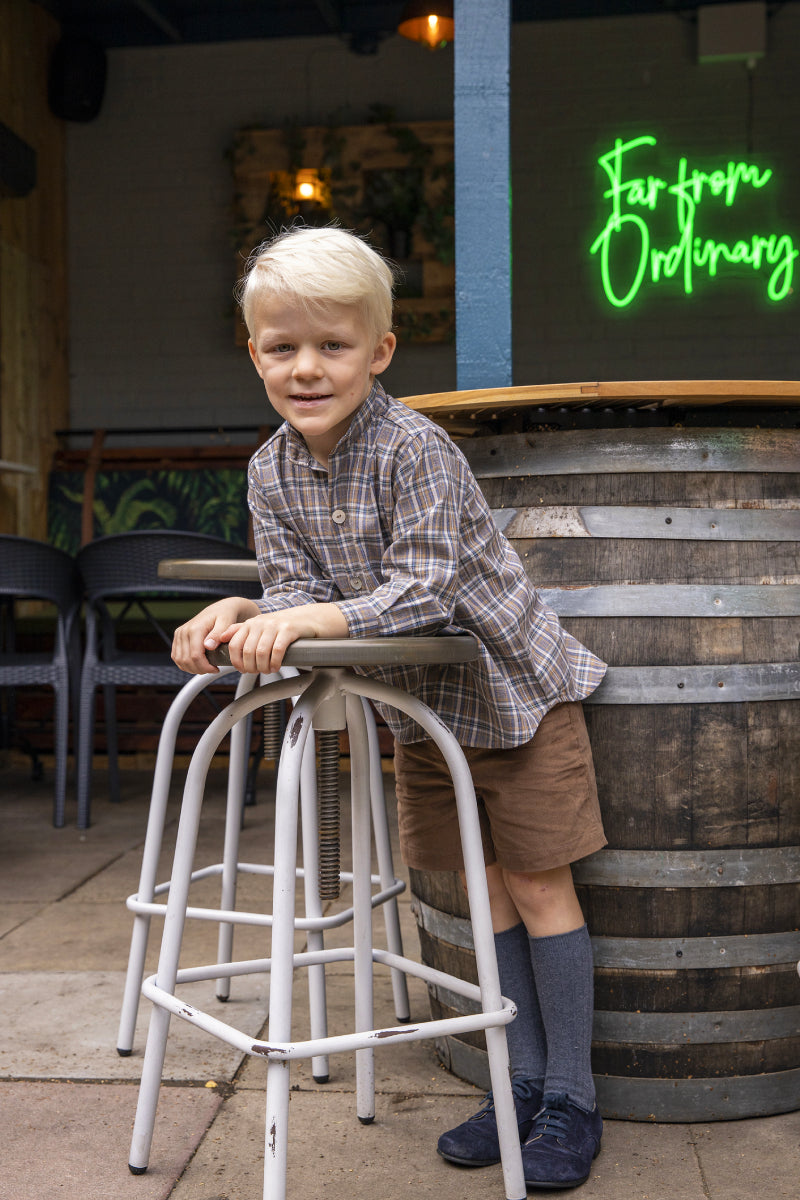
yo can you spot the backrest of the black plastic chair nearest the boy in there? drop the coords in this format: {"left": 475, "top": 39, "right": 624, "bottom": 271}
{"left": 77, "top": 529, "right": 261, "bottom": 600}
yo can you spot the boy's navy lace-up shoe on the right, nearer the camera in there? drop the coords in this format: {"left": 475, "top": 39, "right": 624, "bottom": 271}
{"left": 522, "top": 1092, "right": 603, "bottom": 1188}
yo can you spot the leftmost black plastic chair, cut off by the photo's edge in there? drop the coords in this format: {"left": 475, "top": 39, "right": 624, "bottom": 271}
{"left": 0, "top": 535, "right": 80, "bottom": 828}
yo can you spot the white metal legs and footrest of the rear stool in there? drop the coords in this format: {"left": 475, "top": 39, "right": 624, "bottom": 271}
{"left": 116, "top": 664, "right": 410, "bottom": 1084}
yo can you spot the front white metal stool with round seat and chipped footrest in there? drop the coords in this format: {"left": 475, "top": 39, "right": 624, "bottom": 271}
{"left": 130, "top": 636, "right": 525, "bottom": 1200}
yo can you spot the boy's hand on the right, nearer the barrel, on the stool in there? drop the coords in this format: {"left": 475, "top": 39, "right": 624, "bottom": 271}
{"left": 225, "top": 604, "right": 349, "bottom": 674}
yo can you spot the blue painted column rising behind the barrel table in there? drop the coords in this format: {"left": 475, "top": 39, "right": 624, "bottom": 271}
{"left": 455, "top": 0, "right": 511, "bottom": 390}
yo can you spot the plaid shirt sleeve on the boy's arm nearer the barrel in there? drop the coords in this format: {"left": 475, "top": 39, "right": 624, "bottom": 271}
{"left": 338, "top": 437, "right": 470, "bottom": 637}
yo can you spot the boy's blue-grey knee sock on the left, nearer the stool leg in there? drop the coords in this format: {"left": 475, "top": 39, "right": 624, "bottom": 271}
{"left": 494, "top": 922, "right": 547, "bottom": 1090}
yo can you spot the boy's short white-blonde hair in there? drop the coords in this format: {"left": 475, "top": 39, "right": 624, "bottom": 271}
{"left": 236, "top": 226, "right": 395, "bottom": 341}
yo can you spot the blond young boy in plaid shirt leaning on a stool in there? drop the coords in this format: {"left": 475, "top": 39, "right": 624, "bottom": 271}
{"left": 173, "top": 227, "right": 606, "bottom": 1188}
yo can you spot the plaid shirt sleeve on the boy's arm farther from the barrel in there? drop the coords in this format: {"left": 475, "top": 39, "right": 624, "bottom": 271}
{"left": 247, "top": 479, "right": 341, "bottom": 612}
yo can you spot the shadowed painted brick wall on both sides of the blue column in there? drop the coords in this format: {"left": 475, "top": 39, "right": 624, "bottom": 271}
{"left": 68, "top": 5, "right": 800, "bottom": 441}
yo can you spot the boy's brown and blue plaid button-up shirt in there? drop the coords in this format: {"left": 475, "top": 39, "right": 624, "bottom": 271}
{"left": 248, "top": 384, "right": 606, "bottom": 748}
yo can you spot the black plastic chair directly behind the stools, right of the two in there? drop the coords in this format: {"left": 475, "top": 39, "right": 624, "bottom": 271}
{"left": 77, "top": 529, "right": 261, "bottom": 829}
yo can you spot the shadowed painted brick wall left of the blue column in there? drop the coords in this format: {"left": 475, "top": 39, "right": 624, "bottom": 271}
{"left": 68, "top": 37, "right": 455, "bottom": 441}
